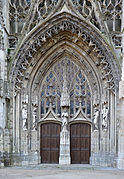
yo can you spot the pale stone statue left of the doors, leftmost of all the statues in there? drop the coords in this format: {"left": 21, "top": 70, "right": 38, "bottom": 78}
{"left": 22, "top": 104, "right": 28, "bottom": 130}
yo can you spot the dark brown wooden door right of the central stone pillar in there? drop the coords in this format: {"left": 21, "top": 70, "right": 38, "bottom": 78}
{"left": 70, "top": 123, "right": 91, "bottom": 164}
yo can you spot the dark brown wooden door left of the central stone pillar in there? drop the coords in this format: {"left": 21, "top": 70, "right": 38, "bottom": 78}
{"left": 40, "top": 123, "right": 60, "bottom": 163}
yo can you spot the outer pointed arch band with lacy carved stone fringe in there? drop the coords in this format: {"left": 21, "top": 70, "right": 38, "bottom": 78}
{"left": 9, "top": 13, "right": 120, "bottom": 90}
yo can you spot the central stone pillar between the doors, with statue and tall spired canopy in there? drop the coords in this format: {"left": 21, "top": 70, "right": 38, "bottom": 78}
{"left": 59, "top": 66, "right": 70, "bottom": 164}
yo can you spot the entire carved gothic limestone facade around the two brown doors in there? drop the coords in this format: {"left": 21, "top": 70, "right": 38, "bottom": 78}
{"left": 0, "top": 0, "right": 124, "bottom": 169}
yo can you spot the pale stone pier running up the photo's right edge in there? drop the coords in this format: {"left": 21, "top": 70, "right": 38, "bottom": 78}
{"left": 118, "top": 0, "right": 124, "bottom": 169}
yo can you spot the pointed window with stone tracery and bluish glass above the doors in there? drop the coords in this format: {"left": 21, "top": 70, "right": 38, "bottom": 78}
{"left": 41, "top": 59, "right": 91, "bottom": 117}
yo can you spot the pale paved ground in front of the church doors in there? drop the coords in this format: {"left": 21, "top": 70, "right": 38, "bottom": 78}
{"left": 0, "top": 165, "right": 124, "bottom": 179}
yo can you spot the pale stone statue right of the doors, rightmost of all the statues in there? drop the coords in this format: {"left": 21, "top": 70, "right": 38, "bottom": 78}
{"left": 102, "top": 105, "right": 109, "bottom": 129}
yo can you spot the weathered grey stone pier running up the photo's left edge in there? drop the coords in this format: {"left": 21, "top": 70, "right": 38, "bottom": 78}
{"left": 0, "top": 0, "right": 11, "bottom": 166}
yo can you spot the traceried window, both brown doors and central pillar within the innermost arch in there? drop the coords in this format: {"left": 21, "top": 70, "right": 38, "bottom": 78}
{"left": 41, "top": 59, "right": 91, "bottom": 164}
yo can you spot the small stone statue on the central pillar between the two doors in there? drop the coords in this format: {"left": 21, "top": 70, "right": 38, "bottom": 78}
{"left": 62, "top": 110, "right": 69, "bottom": 131}
